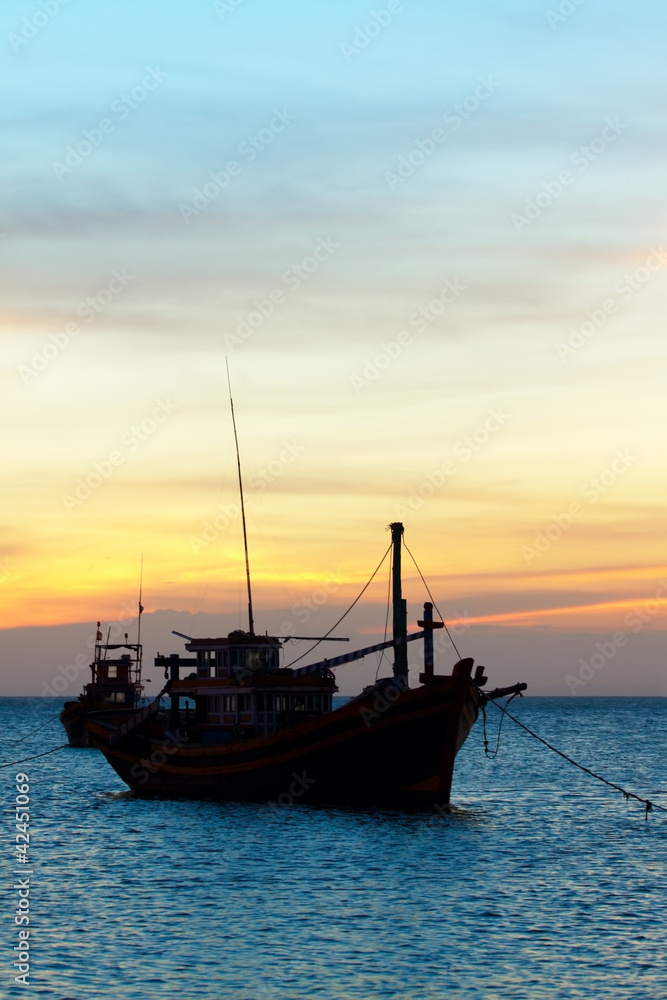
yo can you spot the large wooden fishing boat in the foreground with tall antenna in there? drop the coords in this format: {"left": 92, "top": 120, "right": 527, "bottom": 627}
{"left": 87, "top": 373, "right": 526, "bottom": 808}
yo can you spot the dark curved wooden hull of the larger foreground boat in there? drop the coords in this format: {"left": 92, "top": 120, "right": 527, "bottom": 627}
{"left": 88, "top": 661, "right": 479, "bottom": 807}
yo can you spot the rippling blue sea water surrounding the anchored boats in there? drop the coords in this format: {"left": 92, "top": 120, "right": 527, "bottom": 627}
{"left": 0, "top": 698, "right": 667, "bottom": 1000}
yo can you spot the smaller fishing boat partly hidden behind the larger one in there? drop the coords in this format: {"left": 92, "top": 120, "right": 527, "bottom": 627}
{"left": 60, "top": 620, "right": 144, "bottom": 747}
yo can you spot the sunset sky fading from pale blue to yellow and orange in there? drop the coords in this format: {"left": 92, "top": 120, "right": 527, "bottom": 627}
{"left": 0, "top": 0, "right": 667, "bottom": 694}
